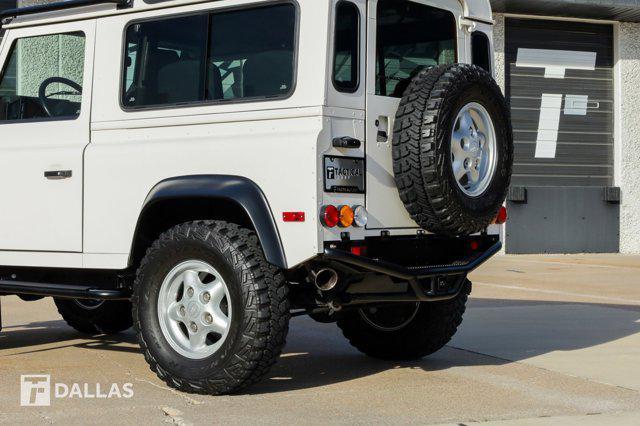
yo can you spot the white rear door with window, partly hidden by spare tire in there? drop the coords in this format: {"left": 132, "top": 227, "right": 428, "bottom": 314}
{"left": 366, "top": 0, "right": 466, "bottom": 229}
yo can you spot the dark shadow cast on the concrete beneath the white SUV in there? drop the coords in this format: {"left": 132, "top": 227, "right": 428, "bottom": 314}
{"left": 0, "top": 299, "right": 640, "bottom": 394}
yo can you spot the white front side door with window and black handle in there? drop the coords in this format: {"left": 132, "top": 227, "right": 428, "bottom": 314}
{"left": 0, "top": 20, "right": 95, "bottom": 252}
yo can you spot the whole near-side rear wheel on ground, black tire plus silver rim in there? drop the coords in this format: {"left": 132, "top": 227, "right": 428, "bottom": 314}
{"left": 133, "top": 221, "right": 289, "bottom": 395}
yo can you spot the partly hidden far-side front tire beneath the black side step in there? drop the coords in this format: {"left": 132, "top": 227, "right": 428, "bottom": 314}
{"left": 53, "top": 298, "right": 133, "bottom": 335}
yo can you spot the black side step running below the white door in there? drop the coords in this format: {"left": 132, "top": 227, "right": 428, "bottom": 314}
{"left": 0, "top": 280, "right": 131, "bottom": 300}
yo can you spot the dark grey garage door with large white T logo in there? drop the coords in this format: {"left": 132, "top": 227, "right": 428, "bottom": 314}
{"left": 505, "top": 18, "right": 619, "bottom": 253}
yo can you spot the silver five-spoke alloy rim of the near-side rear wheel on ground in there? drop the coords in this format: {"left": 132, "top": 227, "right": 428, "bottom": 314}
{"left": 158, "top": 260, "right": 231, "bottom": 359}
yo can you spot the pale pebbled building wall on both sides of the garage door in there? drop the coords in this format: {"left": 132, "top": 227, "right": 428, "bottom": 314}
{"left": 494, "top": 14, "right": 640, "bottom": 254}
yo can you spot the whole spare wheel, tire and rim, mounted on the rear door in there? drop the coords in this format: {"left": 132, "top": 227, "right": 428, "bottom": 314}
{"left": 393, "top": 64, "right": 513, "bottom": 235}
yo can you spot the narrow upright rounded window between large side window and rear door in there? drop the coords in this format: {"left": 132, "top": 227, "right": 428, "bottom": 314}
{"left": 333, "top": 1, "right": 360, "bottom": 93}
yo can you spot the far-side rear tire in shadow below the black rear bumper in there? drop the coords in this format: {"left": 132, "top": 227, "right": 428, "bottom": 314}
{"left": 338, "top": 280, "right": 471, "bottom": 360}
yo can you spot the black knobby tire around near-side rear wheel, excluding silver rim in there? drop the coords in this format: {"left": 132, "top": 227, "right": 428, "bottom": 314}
{"left": 133, "top": 221, "right": 289, "bottom": 395}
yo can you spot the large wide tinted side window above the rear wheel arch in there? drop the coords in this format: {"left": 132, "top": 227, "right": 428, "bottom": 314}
{"left": 122, "top": 3, "right": 296, "bottom": 108}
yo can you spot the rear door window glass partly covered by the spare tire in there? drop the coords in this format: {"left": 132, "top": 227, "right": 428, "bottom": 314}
{"left": 376, "top": 0, "right": 456, "bottom": 98}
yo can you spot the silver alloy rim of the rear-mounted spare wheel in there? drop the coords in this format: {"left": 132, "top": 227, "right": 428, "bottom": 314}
{"left": 451, "top": 102, "right": 497, "bottom": 197}
